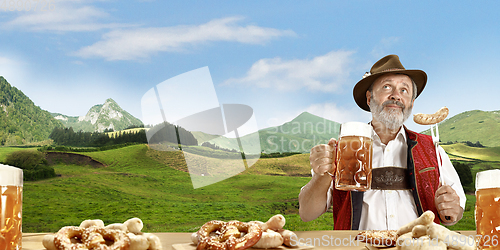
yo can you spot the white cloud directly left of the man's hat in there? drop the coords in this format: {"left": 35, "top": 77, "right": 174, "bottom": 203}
{"left": 224, "top": 50, "right": 354, "bottom": 92}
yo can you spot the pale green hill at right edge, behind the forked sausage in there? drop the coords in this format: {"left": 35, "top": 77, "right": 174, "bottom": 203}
{"left": 423, "top": 110, "right": 500, "bottom": 147}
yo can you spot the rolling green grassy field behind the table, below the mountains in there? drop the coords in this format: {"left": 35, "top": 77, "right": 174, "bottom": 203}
{"left": 0, "top": 145, "right": 500, "bottom": 232}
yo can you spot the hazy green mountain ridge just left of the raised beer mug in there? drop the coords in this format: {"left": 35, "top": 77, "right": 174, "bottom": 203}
{"left": 193, "top": 112, "right": 340, "bottom": 153}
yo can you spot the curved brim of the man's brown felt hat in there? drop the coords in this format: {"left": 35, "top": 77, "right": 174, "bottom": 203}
{"left": 353, "top": 69, "right": 427, "bottom": 112}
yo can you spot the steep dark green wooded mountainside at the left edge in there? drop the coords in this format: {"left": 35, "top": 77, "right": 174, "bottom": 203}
{"left": 0, "top": 76, "right": 63, "bottom": 145}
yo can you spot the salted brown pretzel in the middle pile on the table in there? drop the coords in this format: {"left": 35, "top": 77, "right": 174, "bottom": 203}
{"left": 196, "top": 220, "right": 262, "bottom": 250}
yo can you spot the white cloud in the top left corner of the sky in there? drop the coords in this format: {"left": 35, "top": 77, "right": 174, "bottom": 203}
{"left": 2, "top": 1, "right": 132, "bottom": 32}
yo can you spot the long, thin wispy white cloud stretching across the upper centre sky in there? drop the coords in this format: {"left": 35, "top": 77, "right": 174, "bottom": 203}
{"left": 75, "top": 17, "right": 295, "bottom": 61}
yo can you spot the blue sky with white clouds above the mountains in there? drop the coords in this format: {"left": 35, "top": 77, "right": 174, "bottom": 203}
{"left": 0, "top": 0, "right": 500, "bottom": 135}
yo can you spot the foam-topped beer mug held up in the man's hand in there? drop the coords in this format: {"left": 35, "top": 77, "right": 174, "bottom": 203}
{"left": 335, "top": 122, "right": 373, "bottom": 191}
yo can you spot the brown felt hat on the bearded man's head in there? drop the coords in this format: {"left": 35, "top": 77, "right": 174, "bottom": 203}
{"left": 352, "top": 55, "right": 427, "bottom": 112}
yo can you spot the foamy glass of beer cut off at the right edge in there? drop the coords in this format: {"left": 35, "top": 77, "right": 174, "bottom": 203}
{"left": 475, "top": 169, "right": 500, "bottom": 250}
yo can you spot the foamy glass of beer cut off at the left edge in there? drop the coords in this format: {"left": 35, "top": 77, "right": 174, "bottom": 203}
{"left": 0, "top": 164, "right": 23, "bottom": 250}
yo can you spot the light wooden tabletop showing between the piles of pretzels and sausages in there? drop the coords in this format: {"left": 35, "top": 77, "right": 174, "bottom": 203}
{"left": 23, "top": 231, "right": 476, "bottom": 250}
